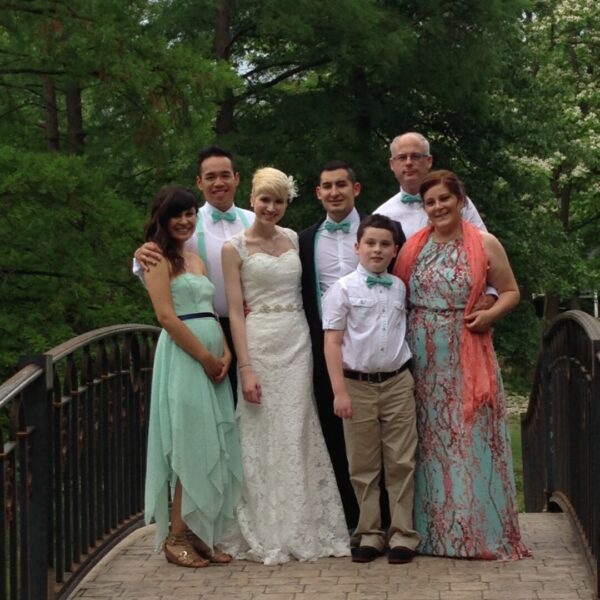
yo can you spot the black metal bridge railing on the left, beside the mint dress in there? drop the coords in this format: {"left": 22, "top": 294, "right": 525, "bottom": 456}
{"left": 0, "top": 325, "right": 160, "bottom": 600}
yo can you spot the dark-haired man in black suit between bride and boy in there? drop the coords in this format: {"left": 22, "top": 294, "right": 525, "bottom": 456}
{"left": 299, "top": 160, "right": 404, "bottom": 529}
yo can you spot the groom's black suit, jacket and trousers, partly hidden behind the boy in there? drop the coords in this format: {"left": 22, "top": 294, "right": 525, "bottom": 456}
{"left": 299, "top": 213, "right": 406, "bottom": 528}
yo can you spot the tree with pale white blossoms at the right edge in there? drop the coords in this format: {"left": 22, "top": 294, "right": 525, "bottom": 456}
{"left": 506, "top": 0, "right": 600, "bottom": 320}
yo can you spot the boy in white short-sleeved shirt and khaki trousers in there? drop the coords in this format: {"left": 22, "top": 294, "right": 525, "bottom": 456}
{"left": 323, "top": 215, "right": 419, "bottom": 564}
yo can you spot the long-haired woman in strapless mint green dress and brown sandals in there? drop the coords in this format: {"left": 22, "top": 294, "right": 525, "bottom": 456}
{"left": 145, "top": 187, "right": 242, "bottom": 568}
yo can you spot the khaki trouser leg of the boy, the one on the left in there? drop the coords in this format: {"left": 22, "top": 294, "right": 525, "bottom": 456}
{"left": 344, "top": 379, "right": 385, "bottom": 551}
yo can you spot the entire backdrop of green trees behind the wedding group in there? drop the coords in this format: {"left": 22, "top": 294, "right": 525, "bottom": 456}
{"left": 0, "top": 0, "right": 600, "bottom": 386}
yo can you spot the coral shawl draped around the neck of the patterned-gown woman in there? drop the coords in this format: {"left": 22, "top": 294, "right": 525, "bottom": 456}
{"left": 394, "top": 220, "right": 498, "bottom": 422}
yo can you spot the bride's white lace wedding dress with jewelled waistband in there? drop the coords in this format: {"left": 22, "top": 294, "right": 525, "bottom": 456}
{"left": 220, "top": 228, "right": 350, "bottom": 565}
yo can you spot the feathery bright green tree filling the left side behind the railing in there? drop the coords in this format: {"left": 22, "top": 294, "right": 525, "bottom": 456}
{"left": 0, "top": 0, "right": 227, "bottom": 376}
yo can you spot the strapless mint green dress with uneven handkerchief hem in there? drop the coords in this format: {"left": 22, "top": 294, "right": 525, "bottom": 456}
{"left": 145, "top": 273, "right": 243, "bottom": 549}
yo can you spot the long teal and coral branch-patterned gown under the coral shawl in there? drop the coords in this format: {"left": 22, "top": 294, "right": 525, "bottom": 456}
{"left": 408, "top": 237, "right": 529, "bottom": 560}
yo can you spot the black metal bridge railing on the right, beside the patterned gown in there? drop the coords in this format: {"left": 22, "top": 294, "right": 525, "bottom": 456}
{"left": 521, "top": 310, "right": 600, "bottom": 597}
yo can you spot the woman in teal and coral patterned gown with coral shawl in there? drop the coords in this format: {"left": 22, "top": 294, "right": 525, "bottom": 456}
{"left": 394, "top": 171, "right": 529, "bottom": 560}
